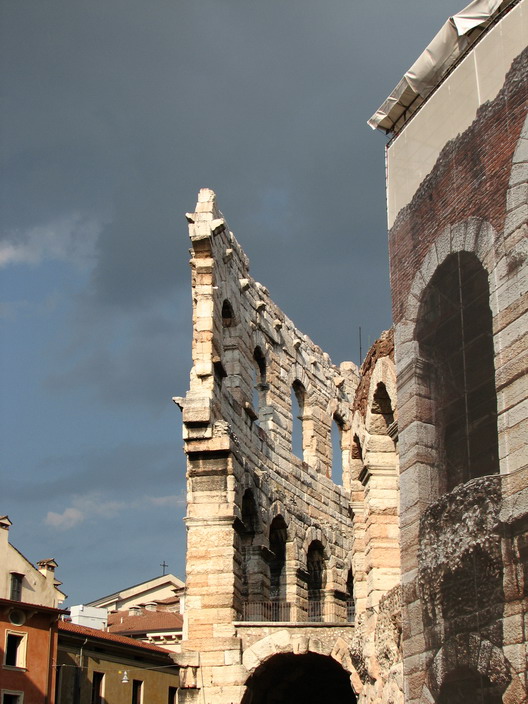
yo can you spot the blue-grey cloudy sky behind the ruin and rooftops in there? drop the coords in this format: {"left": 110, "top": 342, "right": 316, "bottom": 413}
{"left": 0, "top": 0, "right": 463, "bottom": 604}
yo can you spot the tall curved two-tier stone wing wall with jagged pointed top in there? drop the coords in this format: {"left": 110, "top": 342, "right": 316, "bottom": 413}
{"left": 176, "top": 189, "right": 358, "bottom": 702}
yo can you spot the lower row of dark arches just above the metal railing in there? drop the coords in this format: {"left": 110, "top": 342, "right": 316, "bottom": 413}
{"left": 236, "top": 489, "right": 355, "bottom": 622}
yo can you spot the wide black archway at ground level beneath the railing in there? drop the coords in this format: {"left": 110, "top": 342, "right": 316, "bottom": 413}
{"left": 242, "top": 653, "right": 357, "bottom": 704}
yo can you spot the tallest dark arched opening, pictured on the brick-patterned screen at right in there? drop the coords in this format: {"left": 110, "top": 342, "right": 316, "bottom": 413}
{"left": 415, "top": 252, "right": 499, "bottom": 491}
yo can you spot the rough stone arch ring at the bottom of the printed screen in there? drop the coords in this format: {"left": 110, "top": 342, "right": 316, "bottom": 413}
{"left": 420, "top": 633, "right": 528, "bottom": 704}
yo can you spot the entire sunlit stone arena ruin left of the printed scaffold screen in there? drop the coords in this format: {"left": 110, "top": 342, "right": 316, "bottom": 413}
{"left": 175, "top": 189, "right": 401, "bottom": 704}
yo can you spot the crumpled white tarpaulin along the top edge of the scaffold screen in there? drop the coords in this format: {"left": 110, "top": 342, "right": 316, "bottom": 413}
{"left": 368, "top": 0, "right": 514, "bottom": 132}
